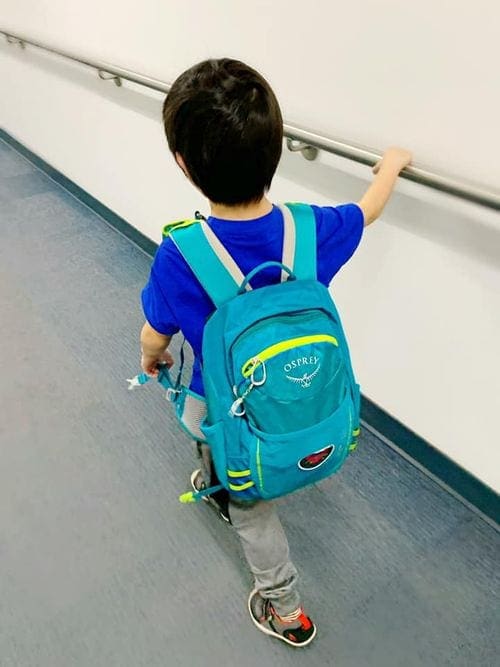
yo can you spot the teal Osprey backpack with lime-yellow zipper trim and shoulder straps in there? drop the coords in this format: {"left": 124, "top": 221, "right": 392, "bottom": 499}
{"left": 131, "top": 204, "right": 360, "bottom": 502}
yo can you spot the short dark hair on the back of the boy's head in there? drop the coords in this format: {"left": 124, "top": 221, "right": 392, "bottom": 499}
{"left": 163, "top": 58, "right": 283, "bottom": 205}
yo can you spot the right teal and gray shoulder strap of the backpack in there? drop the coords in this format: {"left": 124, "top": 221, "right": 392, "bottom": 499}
{"left": 279, "top": 203, "right": 317, "bottom": 280}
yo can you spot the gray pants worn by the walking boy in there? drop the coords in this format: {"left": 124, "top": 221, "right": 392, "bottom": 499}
{"left": 183, "top": 396, "right": 300, "bottom": 616}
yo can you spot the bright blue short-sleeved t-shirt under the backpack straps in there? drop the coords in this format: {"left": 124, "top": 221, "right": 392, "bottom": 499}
{"left": 142, "top": 204, "right": 364, "bottom": 396}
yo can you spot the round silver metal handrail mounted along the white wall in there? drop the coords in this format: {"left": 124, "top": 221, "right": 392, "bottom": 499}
{"left": 0, "top": 30, "right": 500, "bottom": 210}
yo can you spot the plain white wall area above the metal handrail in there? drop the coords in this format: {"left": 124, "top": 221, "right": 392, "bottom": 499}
{"left": 0, "top": 0, "right": 500, "bottom": 186}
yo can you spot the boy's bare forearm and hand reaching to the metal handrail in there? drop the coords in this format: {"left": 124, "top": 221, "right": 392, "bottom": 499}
{"left": 359, "top": 148, "right": 412, "bottom": 227}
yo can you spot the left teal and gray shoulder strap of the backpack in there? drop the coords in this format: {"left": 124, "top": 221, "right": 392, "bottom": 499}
{"left": 170, "top": 220, "right": 251, "bottom": 308}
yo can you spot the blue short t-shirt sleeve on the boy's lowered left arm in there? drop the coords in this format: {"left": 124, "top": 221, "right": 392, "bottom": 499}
{"left": 141, "top": 246, "right": 180, "bottom": 336}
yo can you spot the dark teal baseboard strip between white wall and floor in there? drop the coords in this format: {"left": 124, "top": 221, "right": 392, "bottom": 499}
{"left": 0, "top": 128, "right": 500, "bottom": 524}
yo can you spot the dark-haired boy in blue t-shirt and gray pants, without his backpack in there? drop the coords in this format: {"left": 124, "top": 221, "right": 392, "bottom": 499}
{"left": 141, "top": 59, "right": 411, "bottom": 646}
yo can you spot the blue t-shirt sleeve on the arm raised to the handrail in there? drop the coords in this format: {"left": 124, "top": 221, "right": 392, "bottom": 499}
{"left": 312, "top": 204, "right": 364, "bottom": 285}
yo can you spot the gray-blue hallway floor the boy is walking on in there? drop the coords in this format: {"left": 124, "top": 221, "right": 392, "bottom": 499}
{"left": 0, "top": 137, "right": 500, "bottom": 667}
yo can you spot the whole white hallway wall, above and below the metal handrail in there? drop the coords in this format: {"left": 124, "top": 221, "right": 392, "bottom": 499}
{"left": 0, "top": 0, "right": 500, "bottom": 489}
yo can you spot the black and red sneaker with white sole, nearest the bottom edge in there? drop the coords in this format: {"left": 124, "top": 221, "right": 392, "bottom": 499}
{"left": 248, "top": 590, "right": 316, "bottom": 647}
